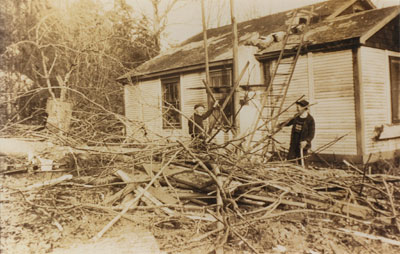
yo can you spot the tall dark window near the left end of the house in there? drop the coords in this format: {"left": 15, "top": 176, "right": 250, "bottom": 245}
{"left": 161, "top": 78, "right": 182, "bottom": 129}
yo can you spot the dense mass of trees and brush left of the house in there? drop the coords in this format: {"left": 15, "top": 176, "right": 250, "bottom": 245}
{"left": 0, "top": 0, "right": 159, "bottom": 139}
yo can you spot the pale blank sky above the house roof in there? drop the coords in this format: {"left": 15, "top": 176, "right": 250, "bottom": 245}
{"left": 95, "top": 0, "right": 400, "bottom": 48}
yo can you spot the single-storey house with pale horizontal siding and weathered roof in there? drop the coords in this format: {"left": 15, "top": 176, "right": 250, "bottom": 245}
{"left": 118, "top": 0, "right": 400, "bottom": 162}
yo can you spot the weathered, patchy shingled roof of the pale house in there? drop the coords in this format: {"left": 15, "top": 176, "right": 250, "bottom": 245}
{"left": 118, "top": 0, "right": 399, "bottom": 80}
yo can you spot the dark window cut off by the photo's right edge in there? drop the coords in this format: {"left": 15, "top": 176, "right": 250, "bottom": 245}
{"left": 389, "top": 56, "right": 400, "bottom": 123}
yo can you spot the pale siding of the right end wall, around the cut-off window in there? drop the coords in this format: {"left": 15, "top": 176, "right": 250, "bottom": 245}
{"left": 359, "top": 47, "right": 400, "bottom": 155}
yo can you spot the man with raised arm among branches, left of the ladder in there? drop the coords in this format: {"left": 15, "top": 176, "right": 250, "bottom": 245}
{"left": 188, "top": 101, "right": 218, "bottom": 143}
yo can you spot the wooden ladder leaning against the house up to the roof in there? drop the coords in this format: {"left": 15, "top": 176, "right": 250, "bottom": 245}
{"left": 247, "top": 6, "right": 314, "bottom": 152}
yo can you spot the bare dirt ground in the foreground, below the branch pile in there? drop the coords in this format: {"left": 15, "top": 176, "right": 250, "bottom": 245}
{"left": 0, "top": 156, "right": 400, "bottom": 254}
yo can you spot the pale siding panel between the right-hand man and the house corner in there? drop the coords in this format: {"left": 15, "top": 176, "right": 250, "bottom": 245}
{"left": 312, "top": 50, "right": 357, "bottom": 155}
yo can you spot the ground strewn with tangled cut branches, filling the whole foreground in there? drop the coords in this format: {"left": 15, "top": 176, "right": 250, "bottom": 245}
{"left": 0, "top": 122, "right": 400, "bottom": 253}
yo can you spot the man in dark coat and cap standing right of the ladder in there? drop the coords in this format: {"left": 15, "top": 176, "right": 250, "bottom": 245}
{"left": 285, "top": 100, "right": 315, "bottom": 167}
